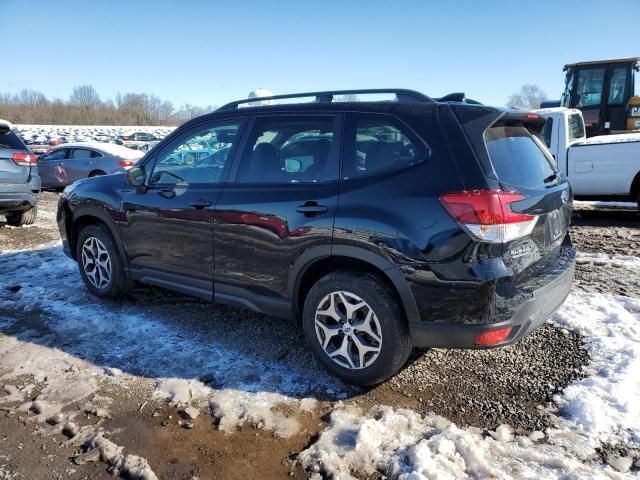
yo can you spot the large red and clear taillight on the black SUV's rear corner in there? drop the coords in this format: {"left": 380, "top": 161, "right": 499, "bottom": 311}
{"left": 440, "top": 190, "right": 538, "bottom": 243}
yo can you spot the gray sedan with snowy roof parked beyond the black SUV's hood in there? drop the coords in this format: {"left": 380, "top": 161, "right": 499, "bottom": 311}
{"left": 38, "top": 142, "right": 144, "bottom": 189}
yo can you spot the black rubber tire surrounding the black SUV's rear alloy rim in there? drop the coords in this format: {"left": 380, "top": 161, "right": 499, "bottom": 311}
{"left": 302, "top": 271, "right": 411, "bottom": 385}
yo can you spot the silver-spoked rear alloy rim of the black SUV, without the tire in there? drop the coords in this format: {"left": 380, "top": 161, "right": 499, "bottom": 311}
{"left": 315, "top": 290, "right": 382, "bottom": 370}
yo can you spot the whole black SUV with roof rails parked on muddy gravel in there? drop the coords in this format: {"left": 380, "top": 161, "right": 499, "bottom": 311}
{"left": 58, "top": 90, "right": 575, "bottom": 384}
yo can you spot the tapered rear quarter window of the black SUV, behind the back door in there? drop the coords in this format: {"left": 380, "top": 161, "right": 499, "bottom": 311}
{"left": 343, "top": 115, "right": 428, "bottom": 179}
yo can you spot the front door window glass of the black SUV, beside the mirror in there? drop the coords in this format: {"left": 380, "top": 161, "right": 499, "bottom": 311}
{"left": 149, "top": 120, "right": 242, "bottom": 185}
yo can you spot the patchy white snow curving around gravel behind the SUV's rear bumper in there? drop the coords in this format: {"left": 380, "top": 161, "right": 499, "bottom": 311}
{"left": 300, "top": 292, "right": 640, "bottom": 480}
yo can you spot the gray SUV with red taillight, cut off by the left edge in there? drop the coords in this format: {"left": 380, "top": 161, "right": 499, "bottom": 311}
{"left": 0, "top": 120, "right": 40, "bottom": 227}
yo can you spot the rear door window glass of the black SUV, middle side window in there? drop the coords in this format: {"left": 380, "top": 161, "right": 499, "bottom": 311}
{"left": 238, "top": 115, "right": 339, "bottom": 183}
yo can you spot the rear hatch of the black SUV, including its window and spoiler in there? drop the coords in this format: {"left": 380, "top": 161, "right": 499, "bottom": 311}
{"left": 453, "top": 106, "right": 572, "bottom": 283}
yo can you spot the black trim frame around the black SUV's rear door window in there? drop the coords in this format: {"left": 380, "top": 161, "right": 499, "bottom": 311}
{"left": 227, "top": 110, "right": 345, "bottom": 187}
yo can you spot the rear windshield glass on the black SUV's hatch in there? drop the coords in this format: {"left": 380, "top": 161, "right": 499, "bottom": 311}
{"left": 484, "top": 126, "right": 556, "bottom": 188}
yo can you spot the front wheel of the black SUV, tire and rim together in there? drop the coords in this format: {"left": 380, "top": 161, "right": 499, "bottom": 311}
{"left": 76, "top": 225, "right": 132, "bottom": 298}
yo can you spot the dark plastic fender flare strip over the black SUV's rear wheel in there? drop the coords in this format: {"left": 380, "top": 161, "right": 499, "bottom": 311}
{"left": 287, "top": 245, "right": 420, "bottom": 323}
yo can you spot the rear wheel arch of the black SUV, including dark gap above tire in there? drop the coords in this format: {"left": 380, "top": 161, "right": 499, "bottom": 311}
{"left": 288, "top": 245, "right": 419, "bottom": 322}
